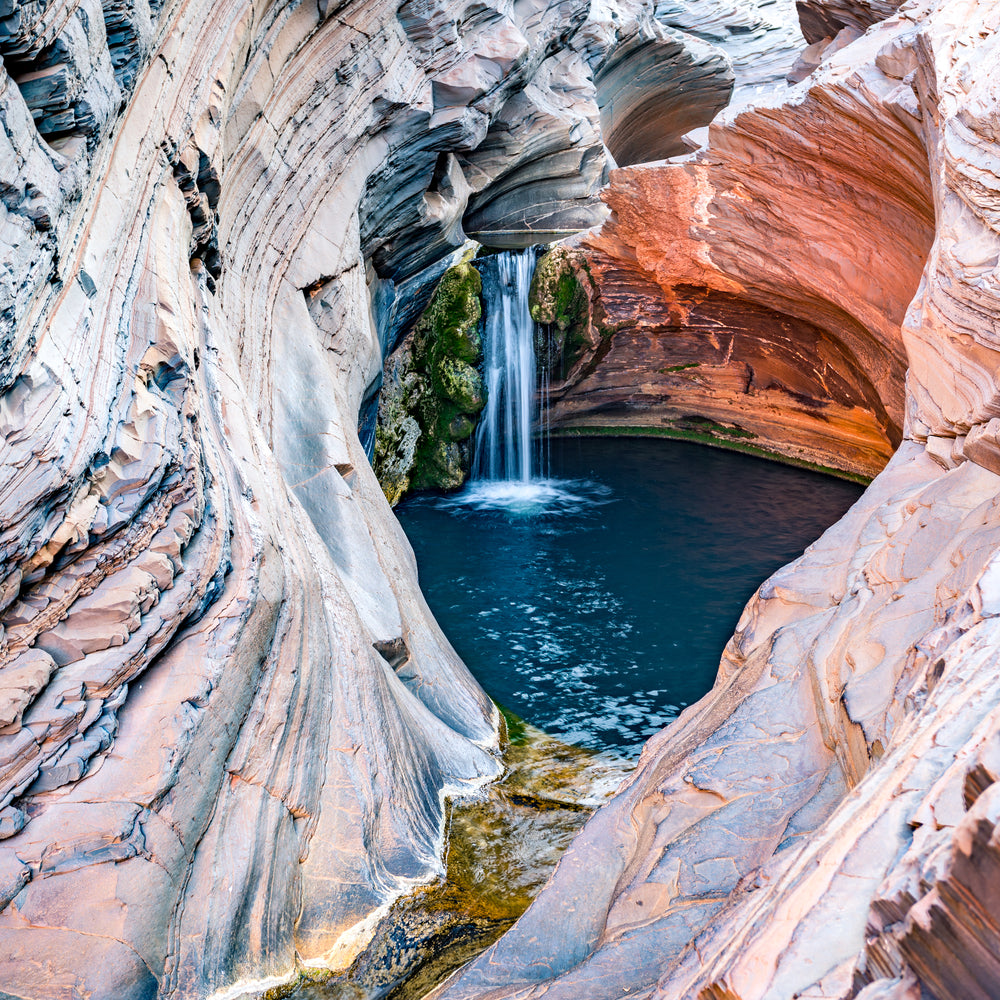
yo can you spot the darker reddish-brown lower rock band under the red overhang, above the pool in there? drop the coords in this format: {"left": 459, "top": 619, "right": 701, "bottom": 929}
{"left": 550, "top": 270, "right": 900, "bottom": 476}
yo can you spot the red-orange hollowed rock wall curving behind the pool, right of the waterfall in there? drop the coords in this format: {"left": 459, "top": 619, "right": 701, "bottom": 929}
{"left": 553, "top": 46, "right": 934, "bottom": 475}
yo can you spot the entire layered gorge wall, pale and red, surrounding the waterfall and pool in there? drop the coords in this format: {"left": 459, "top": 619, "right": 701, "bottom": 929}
{"left": 0, "top": 0, "right": 1000, "bottom": 1000}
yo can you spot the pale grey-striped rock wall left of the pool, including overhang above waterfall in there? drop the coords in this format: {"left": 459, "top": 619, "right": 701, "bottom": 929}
{"left": 0, "top": 0, "right": 795, "bottom": 1000}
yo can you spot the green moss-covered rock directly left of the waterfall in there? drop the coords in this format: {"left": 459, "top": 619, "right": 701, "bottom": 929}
{"left": 373, "top": 263, "right": 486, "bottom": 505}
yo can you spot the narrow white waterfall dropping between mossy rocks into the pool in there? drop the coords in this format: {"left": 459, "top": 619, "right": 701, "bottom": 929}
{"left": 472, "top": 250, "right": 546, "bottom": 484}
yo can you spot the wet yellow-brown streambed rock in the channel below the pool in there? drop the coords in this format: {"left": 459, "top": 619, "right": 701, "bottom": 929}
{"left": 282, "top": 714, "right": 631, "bottom": 1000}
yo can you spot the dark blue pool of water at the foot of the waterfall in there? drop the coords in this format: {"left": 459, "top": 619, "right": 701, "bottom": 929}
{"left": 396, "top": 438, "right": 862, "bottom": 757}
